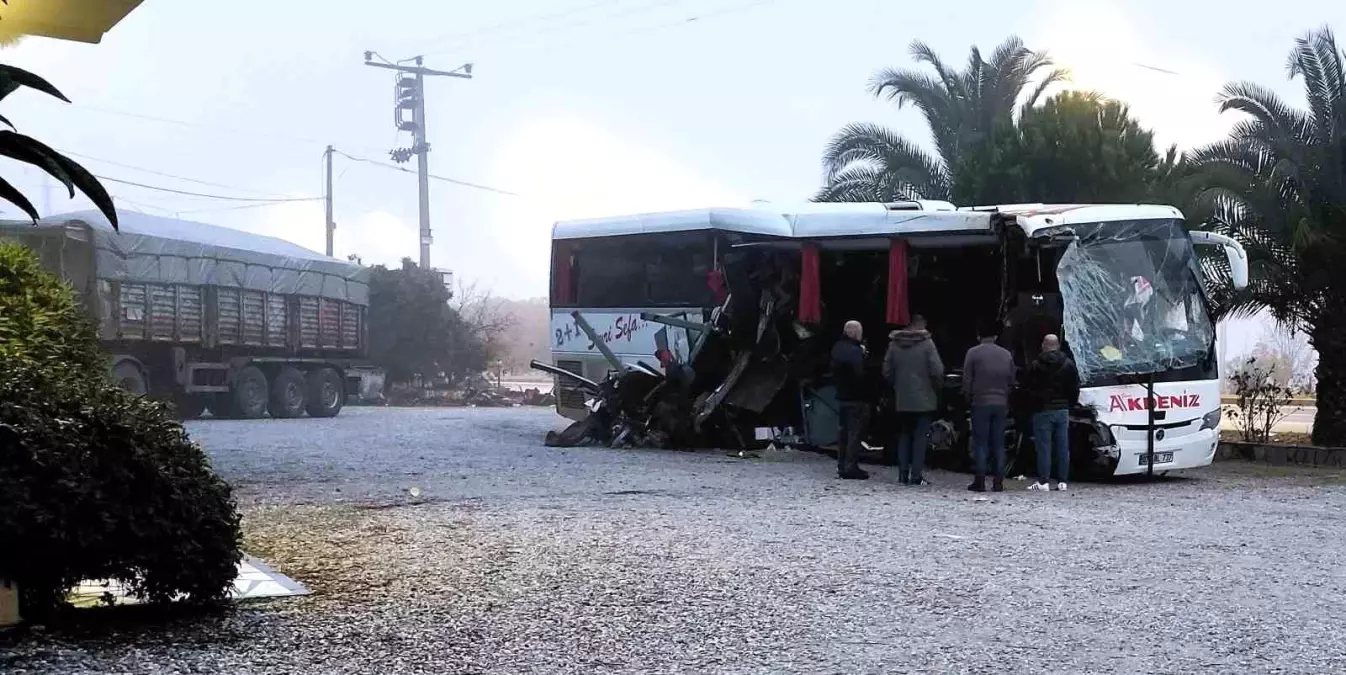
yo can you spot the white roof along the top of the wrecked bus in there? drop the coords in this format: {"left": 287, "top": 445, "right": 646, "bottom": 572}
{"left": 552, "top": 202, "right": 1182, "bottom": 240}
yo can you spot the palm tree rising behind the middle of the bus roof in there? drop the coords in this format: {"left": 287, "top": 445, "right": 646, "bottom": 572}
{"left": 816, "top": 36, "right": 1066, "bottom": 202}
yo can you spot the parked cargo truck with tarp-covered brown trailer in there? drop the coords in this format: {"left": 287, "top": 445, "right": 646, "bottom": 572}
{"left": 0, "top": 212, "right": 376, "bottom": 419}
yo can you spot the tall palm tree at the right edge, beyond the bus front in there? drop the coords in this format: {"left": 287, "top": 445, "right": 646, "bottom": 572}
{"left": 1190, "top": 28, "right": 1346, "bottom": 446}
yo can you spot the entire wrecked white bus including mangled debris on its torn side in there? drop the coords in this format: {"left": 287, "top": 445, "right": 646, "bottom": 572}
{"left": 533, "top": 202, "right": 1246, "bottom": 474}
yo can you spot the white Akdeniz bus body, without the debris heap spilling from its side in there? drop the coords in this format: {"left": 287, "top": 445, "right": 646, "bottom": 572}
{"left": 551, "top": 202, "right": 1248, "bottom": 474}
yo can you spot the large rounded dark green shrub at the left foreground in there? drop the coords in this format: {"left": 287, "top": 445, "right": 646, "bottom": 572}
{"left": 0, "top": 244, "right": 241, "bottom": 618}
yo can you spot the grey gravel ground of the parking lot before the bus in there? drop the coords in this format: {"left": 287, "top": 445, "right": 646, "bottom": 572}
{"left": 0, "top": 408, "right": 1346, "bottom": 675}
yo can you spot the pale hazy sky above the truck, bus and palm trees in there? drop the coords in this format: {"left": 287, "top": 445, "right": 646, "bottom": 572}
{"left": 3, "top": 0, "right": 1346, "bottom": 358}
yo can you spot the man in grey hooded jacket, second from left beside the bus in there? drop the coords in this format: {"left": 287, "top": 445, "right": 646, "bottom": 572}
{"left": 883, "top": 314, "right": 944, "bottom": 485}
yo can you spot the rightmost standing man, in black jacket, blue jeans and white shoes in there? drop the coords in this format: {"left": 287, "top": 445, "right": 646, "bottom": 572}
{"left": 1023, "top": 335, "right": 1079, "bottom": 490}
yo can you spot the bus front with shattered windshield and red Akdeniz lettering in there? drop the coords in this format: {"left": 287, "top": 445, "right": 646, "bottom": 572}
{"left": 999, "top": 205, "right": 1248, "bottom": 476}
